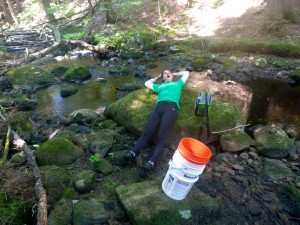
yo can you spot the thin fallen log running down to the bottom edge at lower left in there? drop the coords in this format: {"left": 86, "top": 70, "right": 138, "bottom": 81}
{"left": 12, "top": 130, "right": 47, "bottom": 225}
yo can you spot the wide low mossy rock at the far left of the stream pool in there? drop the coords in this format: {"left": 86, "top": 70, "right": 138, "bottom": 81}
{"left": 5, "top": 65, "right": 55, "bottom": 86}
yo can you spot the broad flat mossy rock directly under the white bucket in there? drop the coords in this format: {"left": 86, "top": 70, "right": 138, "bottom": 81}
{"left": 116, "top": 181, "right": 220, "bottom": 225}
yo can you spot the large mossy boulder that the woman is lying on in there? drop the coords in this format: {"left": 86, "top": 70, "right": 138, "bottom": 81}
{"left": 104, "top": 88, "right": 243, "bottom": 139}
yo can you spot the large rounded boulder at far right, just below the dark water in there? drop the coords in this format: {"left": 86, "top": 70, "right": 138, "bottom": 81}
{"left": 253, "top": 125, "right": 294, "bottom": 159}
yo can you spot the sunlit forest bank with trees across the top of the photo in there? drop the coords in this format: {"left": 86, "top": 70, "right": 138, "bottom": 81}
{"left": 0, "top": 0, "right": 300, "bottom": 47}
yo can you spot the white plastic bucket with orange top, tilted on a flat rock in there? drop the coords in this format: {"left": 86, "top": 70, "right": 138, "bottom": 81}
{"left": 162, "top": 138, "right": 211, "bottom": 200}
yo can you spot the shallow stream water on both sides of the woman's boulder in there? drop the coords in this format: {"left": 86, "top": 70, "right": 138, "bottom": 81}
{"left": 31, "top": 58, "right": 300, "bottom": 131}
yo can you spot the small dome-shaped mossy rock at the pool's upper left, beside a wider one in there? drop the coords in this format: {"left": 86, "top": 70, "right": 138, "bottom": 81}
{"left": 62, "top": 65, "right": 92, "bottom": 82}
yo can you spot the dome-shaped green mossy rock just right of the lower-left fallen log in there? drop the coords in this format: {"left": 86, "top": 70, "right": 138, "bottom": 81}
{"left": 34, "top": 137, "right": 84, "bottom": 166}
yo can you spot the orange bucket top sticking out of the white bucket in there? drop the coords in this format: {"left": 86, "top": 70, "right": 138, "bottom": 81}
{"left": 178, "top": 138, "right": 212, "bottom": 165}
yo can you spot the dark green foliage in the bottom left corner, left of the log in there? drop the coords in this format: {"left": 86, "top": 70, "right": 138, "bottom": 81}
{"left": 0, "top": 191, "right": 27, "bottom": 225}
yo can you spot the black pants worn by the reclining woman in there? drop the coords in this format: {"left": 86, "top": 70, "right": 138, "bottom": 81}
{"left": 133, "top": 101, "right": 178, "bottom": 162}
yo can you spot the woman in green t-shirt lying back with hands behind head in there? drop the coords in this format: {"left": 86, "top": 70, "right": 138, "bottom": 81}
{"left": 124, "top": 70, "right": 189, "bottom": 172}
